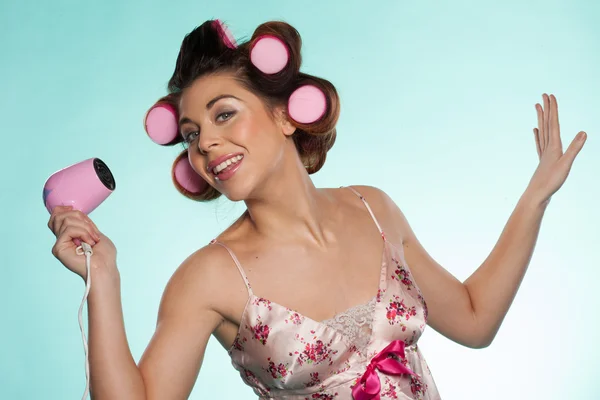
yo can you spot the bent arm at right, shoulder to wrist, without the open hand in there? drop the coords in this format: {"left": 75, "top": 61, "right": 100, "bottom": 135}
{"left": 359, "top": 187, "right": 545, "bottom": 348}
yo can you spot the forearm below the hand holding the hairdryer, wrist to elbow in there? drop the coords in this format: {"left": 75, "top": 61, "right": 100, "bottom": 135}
{"left": 88, "top": 268, "right": 145, "bottom": 400}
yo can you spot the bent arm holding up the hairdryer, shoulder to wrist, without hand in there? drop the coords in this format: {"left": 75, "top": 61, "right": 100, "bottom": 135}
{"left": 88, "top": 248, "right": 221, "bottom": 400}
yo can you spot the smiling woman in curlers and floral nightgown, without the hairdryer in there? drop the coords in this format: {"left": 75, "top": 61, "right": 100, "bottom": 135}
{"left": 49, "top": 21, "right": 585, "bottom": 400}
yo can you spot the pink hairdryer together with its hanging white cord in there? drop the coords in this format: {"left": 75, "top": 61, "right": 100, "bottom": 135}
{"left": 43, "top": 158, "right": 115, "bottom": 400}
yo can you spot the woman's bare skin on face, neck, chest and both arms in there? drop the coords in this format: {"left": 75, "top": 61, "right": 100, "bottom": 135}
{"left": 50, "top": 68, "right": 583, "bottom": 399}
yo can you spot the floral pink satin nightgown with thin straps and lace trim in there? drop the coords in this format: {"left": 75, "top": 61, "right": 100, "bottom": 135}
{"left": 212, "top": 187, "right": 440, "bottom": 400}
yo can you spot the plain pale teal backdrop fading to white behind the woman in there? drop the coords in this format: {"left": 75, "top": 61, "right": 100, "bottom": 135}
{"left": 0, "top": 0, "right": 600, "bottom": 400}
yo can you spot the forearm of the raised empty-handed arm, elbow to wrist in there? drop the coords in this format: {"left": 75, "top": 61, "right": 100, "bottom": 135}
{"left": 464, "top": 192, "right": 546, "bottom": 345}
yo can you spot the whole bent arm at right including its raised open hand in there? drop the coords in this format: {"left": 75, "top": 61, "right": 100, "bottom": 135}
{"left": 358, "top": 94, "right": 586, "bottom": 348}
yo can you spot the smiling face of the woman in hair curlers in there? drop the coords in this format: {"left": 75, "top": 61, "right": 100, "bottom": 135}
{"left": 179, "top": 73, "right": 295, "bottom": 201}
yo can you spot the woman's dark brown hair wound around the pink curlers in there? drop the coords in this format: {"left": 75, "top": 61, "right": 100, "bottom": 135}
{"left": 152, "top": 21, "right": 340, "bottom": 201}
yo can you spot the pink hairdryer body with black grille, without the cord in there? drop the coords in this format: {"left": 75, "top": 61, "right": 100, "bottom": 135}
{"left": 43, "top": 158, "right": 116, "bottom": 214}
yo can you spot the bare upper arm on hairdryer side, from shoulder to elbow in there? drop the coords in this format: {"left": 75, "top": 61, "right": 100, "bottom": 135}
{"left": 139, "top": 248, "right": 227, "bottom": 400}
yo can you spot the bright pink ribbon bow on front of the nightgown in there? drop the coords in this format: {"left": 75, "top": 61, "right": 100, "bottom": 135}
{"left": 352, "top": 340, "right": 416, "bottom": 400}
